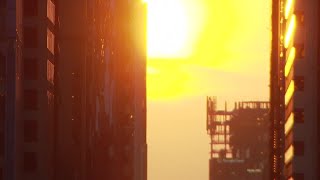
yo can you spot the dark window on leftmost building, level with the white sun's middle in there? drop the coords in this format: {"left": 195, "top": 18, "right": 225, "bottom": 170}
{"left": 23, "top": 26, "right": 38, "bottom": 48}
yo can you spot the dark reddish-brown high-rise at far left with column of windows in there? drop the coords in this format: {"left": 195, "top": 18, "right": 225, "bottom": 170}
{"left": 0, "top": 0, "right": 56, "bottom": 179}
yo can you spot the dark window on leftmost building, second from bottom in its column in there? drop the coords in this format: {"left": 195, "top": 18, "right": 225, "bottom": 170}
{"left": 23, "top": 120, "right": 38, "bottom": 143}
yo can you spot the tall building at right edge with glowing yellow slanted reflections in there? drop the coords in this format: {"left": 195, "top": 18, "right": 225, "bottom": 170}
{"left": 270, "top": 0, "right": 320, "bottom": 180}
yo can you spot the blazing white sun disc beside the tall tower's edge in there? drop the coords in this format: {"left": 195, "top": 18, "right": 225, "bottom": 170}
{"left": 146, "top": 0, "right": 190, "bottom": 58}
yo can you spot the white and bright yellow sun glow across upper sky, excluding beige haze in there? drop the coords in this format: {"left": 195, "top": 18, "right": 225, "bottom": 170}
{"left": 144, "top": 0, "right": 271, "bottom": 100}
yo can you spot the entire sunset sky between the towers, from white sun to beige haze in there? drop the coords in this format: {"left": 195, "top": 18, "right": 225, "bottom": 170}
{"left": 146, "top": 0, "right": 271, "bottom": 180}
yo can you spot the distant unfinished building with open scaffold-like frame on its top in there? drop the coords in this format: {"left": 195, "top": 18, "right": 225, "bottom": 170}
{"left": 207, "top": 97, "right": 270, "bottom": 180}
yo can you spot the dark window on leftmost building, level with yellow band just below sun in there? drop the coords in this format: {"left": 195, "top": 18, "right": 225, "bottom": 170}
{"left": 24, "top": 58, "right": 39, "bottom": 80}
